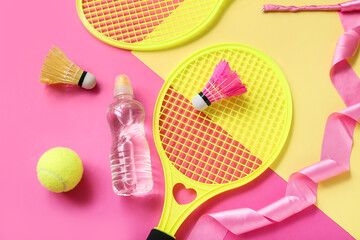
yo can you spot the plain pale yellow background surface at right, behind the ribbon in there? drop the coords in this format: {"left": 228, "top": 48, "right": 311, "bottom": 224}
{"left": 133, "top": 0, "right": 360, "bottom": 238}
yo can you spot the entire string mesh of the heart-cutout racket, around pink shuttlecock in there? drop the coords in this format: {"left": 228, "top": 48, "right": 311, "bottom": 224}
{"left": 158, "top": 47, "right": 291, "bottom": 184}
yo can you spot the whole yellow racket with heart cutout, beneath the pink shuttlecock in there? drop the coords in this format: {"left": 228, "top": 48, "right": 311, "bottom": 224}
{"left": 148, "top": 44, "right": 292, "bottom": 240}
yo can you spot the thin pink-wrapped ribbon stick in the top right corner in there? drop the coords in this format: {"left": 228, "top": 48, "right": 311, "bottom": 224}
{"left": 263, "top": 0, "right": 360, "bottom": 12}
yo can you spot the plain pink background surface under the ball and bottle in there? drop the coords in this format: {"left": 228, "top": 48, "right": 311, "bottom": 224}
{"left": 0, "top": 0, "right": 353, "bottom": 240}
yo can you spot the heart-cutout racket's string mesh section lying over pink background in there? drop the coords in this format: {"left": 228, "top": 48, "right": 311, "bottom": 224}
{"left": 159, "top": 87, "right": 262, "bottom": 184}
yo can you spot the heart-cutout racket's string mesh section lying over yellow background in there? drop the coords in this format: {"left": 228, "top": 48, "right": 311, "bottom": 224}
{"left": 172, "top": 48, "right": 288, "bottom": 161}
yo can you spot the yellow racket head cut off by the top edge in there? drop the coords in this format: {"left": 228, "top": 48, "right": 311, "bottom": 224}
{"left": 76, "top": 0, "right": 224, "bottom": 51}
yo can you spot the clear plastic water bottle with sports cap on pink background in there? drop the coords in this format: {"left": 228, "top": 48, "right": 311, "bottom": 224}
{"left": 107, "top": 75, "right": 153, "bottom": 196}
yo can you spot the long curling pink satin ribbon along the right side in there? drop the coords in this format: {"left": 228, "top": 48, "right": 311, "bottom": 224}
{"left": 188, "top": 13, "right": 360, "bottom": 240}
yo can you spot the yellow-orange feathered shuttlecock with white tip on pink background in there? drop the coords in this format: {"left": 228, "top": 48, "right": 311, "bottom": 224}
{"left": 40, "top": 47, "right": 96, "bottom": 89}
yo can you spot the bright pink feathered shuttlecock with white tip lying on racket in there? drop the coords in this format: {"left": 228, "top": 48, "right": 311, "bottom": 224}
{"left": 192, "top": 60, "right": 247, "bottom": 111}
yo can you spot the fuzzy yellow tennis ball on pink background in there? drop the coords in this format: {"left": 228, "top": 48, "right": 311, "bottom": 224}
{"left": 36, "top": 147, "right": 84, "bottom": 193}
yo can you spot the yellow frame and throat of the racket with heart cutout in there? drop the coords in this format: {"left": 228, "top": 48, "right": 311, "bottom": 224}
{"left": 153, "top": 44, "right": 292, "bottom": 237}
